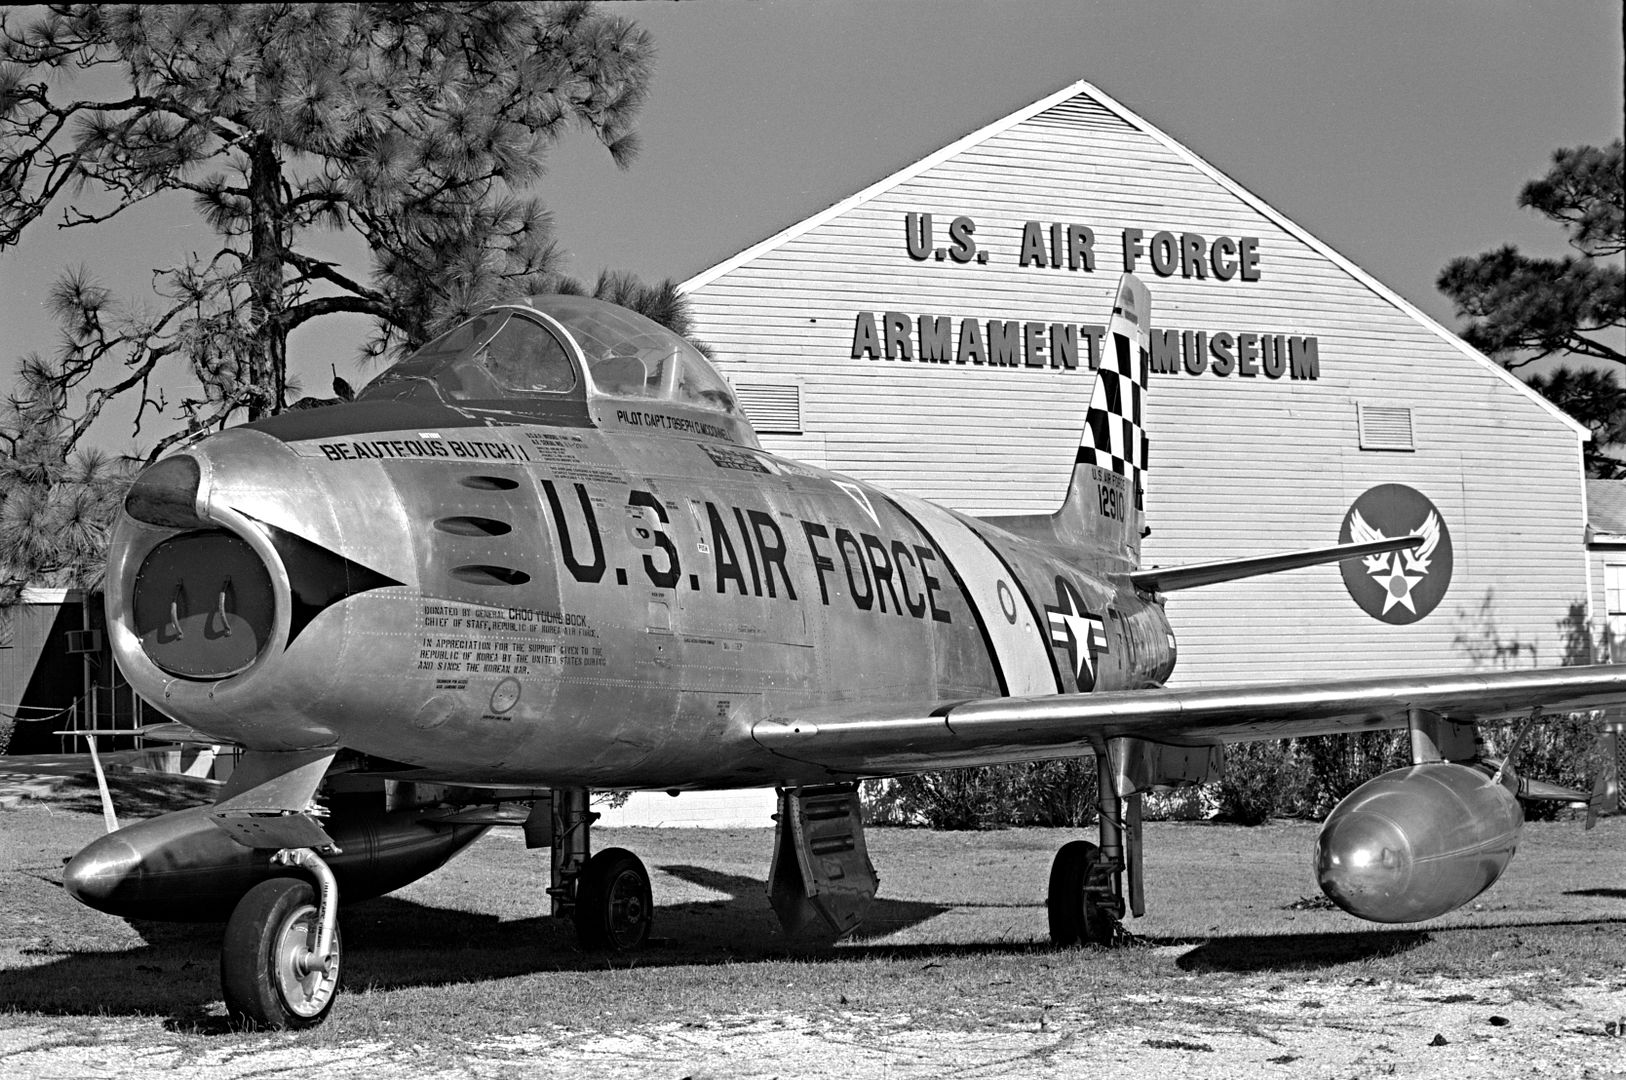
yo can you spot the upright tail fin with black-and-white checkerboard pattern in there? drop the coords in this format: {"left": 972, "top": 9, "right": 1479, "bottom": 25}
{"left": 1054, "top": 273, "right": 1151, "bottom": 568}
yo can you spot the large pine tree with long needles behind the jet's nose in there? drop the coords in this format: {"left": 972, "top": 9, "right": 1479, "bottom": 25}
{"left": 0, "top": 3, "right": 660, "bottom": 460}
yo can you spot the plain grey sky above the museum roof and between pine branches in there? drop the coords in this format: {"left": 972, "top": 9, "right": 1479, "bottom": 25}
{"left": 0, "top": 0, "right": 1626, "bottom": 449}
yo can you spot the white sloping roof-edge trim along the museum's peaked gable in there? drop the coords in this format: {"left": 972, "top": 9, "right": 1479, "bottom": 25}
{"left": 678, "top": 80, "right": 1592, "bottom": 441}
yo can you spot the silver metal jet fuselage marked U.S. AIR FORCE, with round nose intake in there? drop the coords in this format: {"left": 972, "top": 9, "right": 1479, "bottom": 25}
{"left": 109, "top": 297, "right": 1174, "bottom": 789}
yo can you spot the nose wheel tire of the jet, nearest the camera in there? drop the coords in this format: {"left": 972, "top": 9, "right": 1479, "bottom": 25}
{"left": 220, "top": 877, "right": 341, "bottom": 1028}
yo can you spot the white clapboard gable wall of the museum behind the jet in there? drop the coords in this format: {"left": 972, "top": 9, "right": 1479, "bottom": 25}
{"left": 685, "top": 83, "right": 1589, "bottom": 685}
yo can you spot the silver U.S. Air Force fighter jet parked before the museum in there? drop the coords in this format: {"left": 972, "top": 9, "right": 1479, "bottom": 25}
{"left": 65, "top": 275, "right": 1626, "bottom": 1026}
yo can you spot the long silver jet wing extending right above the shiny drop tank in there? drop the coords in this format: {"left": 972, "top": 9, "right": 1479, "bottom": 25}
{"left": 751, "top": 665, "right": 1626, "bottom": 776}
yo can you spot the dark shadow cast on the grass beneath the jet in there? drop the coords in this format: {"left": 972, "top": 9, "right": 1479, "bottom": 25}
{"left": 0, "top": 864, "right": 1619, "bottom": 1036}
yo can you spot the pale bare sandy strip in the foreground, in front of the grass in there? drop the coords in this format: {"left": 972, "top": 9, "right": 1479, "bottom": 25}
{"left": 0, "top": 976, "right": 1626, "bottom": 1080}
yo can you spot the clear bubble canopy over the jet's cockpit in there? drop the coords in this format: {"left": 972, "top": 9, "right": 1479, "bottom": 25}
{"left": 358, "top": 294, "right": 741, "bottom": 418}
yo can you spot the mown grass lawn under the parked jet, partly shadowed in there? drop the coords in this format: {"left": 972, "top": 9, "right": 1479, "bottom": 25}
{"left": 0, "top": 770, "right": 1626, "bottom": 1046}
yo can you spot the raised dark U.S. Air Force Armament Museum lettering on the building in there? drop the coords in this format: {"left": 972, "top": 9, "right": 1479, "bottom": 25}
{"left": 852, "top": 211, "right": 1320, "bottom": 379}
